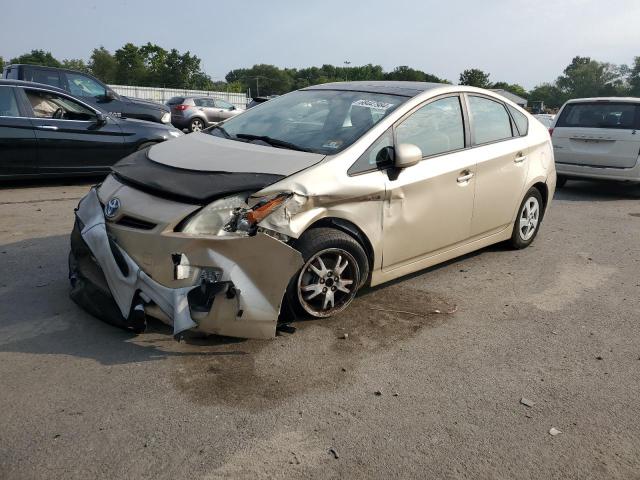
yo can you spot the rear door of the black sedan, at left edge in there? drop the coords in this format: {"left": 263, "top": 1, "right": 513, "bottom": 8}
{"left": 0, "top": 85, "right": 38, "bottom": 177}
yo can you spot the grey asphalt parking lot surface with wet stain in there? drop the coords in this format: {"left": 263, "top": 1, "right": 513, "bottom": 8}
{"left": 0, "top": 181, "right": 640, "bottom": 479}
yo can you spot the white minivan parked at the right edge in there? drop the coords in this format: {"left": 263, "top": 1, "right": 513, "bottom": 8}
{"left": 551, "top": 97, "right": 640, "bottom": 186}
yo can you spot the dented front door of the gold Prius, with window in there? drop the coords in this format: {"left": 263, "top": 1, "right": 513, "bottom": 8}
{"left": 382, "top": 95, "right": 475, "bottom": 270}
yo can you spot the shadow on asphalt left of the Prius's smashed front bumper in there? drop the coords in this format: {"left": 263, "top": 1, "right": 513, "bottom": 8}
{"left": 0, "top": 235, "right": 246, "bottom": 365}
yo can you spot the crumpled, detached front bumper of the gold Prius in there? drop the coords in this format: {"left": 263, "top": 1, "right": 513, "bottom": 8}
{"left": 70, "top": 189, "right": 303, "bottom": 338}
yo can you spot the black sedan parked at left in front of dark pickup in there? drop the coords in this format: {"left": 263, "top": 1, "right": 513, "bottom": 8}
{"left": 0, "top": 80, "right": 183, "bottom": 179}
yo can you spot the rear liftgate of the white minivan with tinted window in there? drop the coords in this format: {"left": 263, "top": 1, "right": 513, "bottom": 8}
{"left": 551, "top": 101, "right": 640, "bottom": 168}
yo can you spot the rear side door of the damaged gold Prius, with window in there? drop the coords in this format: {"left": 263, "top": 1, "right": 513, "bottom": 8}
{"left": 466, "top": 94, "right": 529, "bottom": 237}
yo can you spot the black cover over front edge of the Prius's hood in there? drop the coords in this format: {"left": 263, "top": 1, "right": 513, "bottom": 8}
{"left": 111, "top": 149, "right": 286, "bottom": 205}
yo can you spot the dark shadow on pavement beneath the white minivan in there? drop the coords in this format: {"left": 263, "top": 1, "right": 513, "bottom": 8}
{"left": 554, "top": 180, "right": 640, "bottom": 202}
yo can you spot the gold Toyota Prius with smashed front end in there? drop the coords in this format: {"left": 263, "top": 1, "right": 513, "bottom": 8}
{"left": 69, "top": 82, "right": 556, "bottom": 338}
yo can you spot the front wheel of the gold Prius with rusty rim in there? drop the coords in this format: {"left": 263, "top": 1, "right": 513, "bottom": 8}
{"left": 297, "top": 248, "right": 360, "bottom": 317}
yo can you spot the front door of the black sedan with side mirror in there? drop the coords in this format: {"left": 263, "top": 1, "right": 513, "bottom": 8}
{"left": 23, "top": 88, "right": 128, "bottom": 173}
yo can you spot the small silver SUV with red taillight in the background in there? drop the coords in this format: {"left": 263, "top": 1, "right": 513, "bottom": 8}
{"left": 167, "top": 97, "right": 244, "bottom": 132}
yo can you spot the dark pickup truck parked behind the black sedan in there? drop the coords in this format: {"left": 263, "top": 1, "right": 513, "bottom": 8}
{"left": 3, "top": 64, "right": 171, "bottom": 123}
